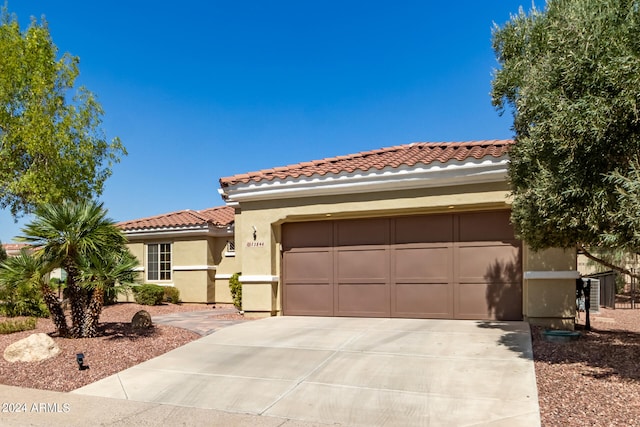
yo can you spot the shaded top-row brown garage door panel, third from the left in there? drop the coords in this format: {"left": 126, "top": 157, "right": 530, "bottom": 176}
{"left": 394, "top": 215, "right": 454, "bottom": 244}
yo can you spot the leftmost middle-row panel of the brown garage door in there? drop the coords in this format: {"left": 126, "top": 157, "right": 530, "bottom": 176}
{"left": 283, "top": 250, "right": 333, "bottom": 283}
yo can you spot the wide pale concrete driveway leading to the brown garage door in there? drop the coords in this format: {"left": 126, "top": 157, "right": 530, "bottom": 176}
{"left": 72, "top": 317, "right": 540, "bottom": 427}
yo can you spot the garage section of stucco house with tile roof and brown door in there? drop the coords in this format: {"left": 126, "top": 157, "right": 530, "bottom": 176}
{"left": 220, "top": 140, "right": 578, "bottom": 328}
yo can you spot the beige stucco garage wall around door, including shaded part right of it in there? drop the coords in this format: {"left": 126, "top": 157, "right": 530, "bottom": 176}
{"left": 235, "top": 182, "right": 576, "bottom": 328}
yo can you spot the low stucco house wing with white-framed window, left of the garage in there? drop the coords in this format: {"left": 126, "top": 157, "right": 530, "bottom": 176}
{"left": 117, "top": 206, "right": 239, "bottom": 303}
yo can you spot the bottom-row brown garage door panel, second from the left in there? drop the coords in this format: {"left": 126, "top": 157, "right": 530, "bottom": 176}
{"left": 335, "top": 283, "right": 391, "bottom": 317}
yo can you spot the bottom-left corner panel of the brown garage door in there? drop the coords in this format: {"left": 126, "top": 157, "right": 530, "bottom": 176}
{"left": 283, "top": 283, "right": 334, "bottom": 316}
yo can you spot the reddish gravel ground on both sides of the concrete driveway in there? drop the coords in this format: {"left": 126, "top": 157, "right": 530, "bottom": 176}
{"left": 0, "top": 303, "right": 640, "bottom": 427}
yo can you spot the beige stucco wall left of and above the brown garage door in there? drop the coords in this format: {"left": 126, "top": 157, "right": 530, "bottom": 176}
{"left": 235, "top": 183, "right": 509, "bottom": 315}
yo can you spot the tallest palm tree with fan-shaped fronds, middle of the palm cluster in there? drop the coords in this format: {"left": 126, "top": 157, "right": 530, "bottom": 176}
{"left": 19, "top": 201, "right": 136, "bottom": 338}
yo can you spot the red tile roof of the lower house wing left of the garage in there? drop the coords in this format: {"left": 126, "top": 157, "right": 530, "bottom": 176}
{"left": 117, "top": 206, "right": 235, "bottom": 230}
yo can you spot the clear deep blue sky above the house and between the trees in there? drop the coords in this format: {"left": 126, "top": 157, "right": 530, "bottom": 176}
{"left": 0, "top": 0, "right": 530, "bottom": 243}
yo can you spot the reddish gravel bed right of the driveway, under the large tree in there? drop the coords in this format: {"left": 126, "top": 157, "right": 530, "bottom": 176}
{"left": 531, "top": 308, "right": 640, "bottom": 426}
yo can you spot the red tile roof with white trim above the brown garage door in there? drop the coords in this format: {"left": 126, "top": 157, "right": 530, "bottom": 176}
{"left": 218, "top": 140, "right": 514, "bottom": 205}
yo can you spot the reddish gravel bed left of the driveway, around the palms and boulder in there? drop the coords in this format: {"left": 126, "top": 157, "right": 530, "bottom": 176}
{"left": 0, "top": 303, "right": 241, "bottom": 391}
